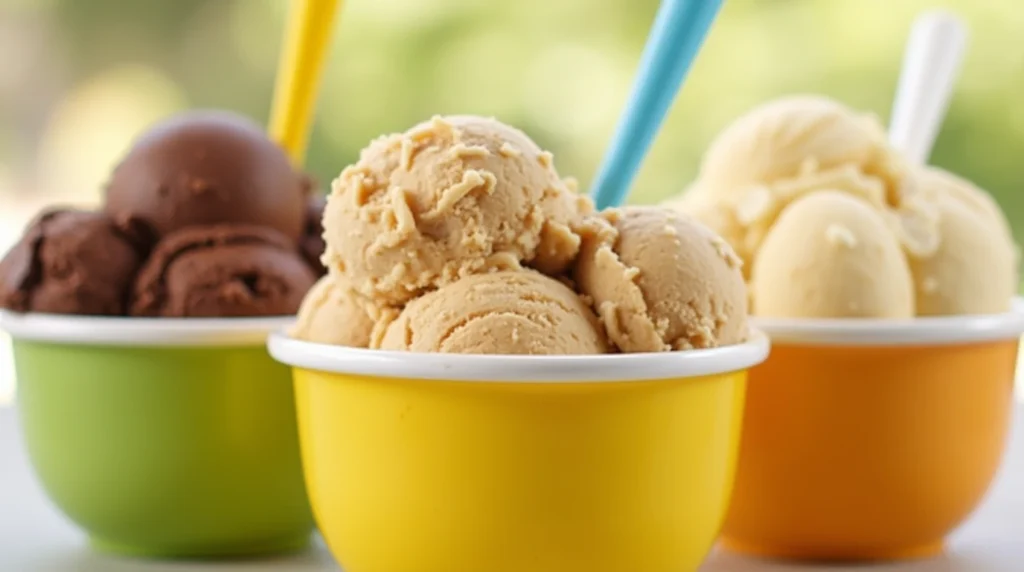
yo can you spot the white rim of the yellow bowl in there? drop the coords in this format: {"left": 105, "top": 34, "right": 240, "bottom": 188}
{"left": 267, "top": 331, "right": 770, "bottom": 383}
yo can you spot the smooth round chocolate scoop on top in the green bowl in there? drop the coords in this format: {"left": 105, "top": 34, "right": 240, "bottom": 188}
{"left": 105, "top": 112, "right": 309, "bottom": 240}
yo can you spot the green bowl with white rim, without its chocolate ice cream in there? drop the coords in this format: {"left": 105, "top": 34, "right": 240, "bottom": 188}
{"left": 0, "top": 312, "right": 313, "bottom": 558}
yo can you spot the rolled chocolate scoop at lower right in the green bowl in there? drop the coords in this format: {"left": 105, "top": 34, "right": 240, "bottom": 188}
{"left": 130, "top": 225, "right": 316, "bottom": 317}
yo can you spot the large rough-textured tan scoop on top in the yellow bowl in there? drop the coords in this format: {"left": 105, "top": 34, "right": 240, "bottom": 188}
{"left": 324, "top": 116, "right": 591, "bottom": 305}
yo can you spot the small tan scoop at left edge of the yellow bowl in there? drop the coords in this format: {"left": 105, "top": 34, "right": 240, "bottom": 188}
{"left": 291, "top": 273, "right": 396, "bottom": 348}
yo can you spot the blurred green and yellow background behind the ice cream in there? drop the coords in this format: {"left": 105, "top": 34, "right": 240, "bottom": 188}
{"left": 0, "top": 0, "right": 1024, "bottom": 393}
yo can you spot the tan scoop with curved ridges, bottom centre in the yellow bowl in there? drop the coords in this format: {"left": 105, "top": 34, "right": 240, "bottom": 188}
{"left": 379, "top": 270, "right": 607, "bottom": 355}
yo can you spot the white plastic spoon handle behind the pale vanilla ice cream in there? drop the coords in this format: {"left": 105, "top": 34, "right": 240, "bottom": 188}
{"left": 889, "top": 11, "right": 967, "bottom": 165}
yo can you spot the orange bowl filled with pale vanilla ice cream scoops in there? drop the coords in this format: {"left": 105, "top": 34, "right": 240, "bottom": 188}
{"left": 667, "top": 95, "right": 1024, "bottom": 561}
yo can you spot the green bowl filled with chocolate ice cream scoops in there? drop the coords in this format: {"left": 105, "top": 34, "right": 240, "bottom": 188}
{"left": 0, "top": 112, "right": 322, "bottom": 558}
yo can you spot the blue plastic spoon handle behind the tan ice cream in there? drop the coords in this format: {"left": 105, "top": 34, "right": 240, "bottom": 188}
{"left": 592, "top": 0, "right": 722, "bottom": 209}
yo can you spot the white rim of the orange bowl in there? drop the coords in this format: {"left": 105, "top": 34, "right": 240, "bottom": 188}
{"left": 751, "top": 297, "right": 1024, "bottom": 347}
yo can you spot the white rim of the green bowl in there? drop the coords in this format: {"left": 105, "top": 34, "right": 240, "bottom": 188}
{"left": 0, "top": 310, "right": 295, "bottom": 347}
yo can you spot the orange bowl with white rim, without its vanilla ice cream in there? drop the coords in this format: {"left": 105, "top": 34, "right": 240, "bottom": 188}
{"left": 723, "top": 301, "right": 1024, "bottom": 561}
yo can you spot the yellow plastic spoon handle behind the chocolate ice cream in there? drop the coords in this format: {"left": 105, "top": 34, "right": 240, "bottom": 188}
{"left": 269, "top": 0, "right": 341, "bottom": 167}
